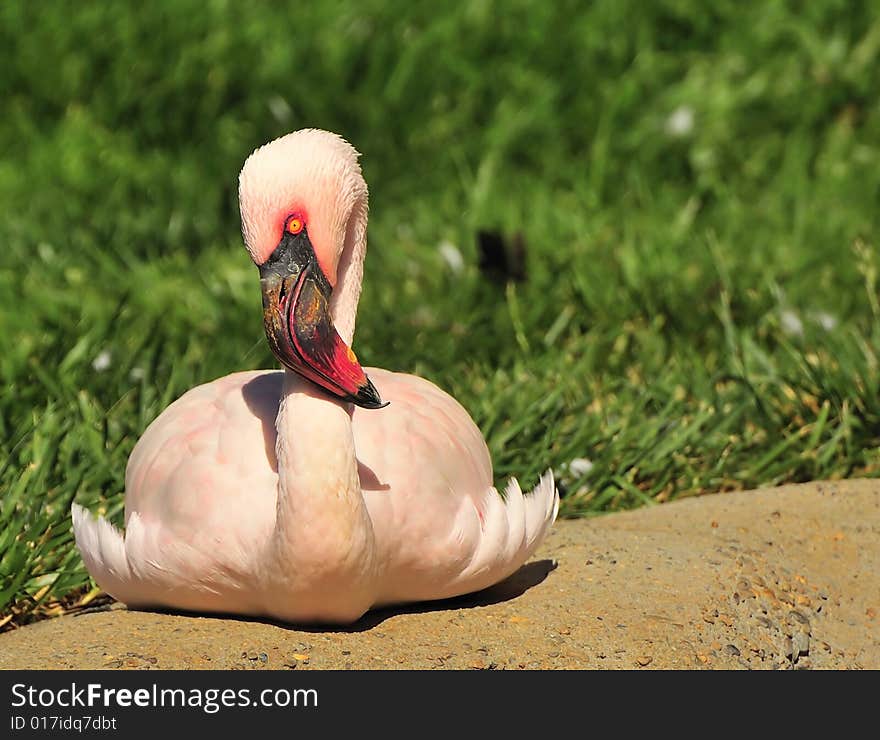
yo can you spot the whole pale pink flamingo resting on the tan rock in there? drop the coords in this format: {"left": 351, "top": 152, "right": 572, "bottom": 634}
{"left": 72, "top": 129, "right": 559, "bottom": 624}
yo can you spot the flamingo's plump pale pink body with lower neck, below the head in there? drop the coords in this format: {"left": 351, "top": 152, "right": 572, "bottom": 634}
{"left": 73, "top": 134, "right": 558, "bottom": 622}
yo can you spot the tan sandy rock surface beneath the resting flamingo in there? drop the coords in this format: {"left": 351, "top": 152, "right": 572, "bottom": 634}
{"left": 0, "top": 481, "right": 880, "bottom": 670}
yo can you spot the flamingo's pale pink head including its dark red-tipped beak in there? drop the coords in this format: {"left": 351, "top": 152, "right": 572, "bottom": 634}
{"left": 238, "top": 129, "right": 385, "bottom": 408}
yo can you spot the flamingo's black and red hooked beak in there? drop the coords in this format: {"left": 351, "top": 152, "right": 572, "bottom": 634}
{"left": 259, "top": 231, "right": 388, "bottom": 409}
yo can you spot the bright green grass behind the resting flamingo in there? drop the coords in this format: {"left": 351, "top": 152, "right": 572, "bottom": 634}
{"left": 0, "top": 0, "right": 880, "bottom": 628}
